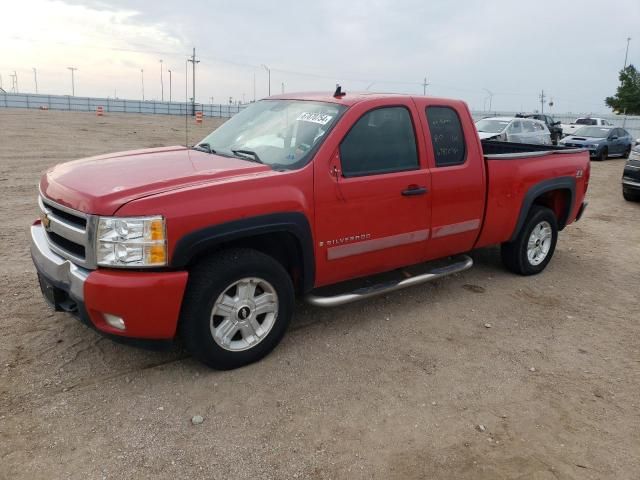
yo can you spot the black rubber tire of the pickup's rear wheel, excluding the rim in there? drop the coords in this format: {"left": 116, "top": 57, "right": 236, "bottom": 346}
{"left": 500, "top": 205, "right": 558, "bottom": 275}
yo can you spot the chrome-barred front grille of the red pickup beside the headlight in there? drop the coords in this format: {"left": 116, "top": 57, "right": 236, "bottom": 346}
{"left": 38, "top": 196, "right": 95, "bottom": 268}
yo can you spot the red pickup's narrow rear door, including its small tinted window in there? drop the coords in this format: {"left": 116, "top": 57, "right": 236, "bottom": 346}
{"left": 416, "top": 98, "right": 486, "bottom": 259}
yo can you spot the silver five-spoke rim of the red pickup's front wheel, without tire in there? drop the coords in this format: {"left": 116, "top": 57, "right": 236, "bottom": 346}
{"left": 209, "top": 277, "right": 278, "bottom": 352}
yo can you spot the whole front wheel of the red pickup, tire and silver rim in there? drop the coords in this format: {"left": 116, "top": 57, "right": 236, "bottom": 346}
{"left": 180, "top": 249, "right": 294, "bottom": 370}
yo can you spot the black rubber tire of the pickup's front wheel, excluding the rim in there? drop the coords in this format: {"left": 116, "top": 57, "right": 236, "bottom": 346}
{"left": 180, "top": 248, "right": 295, "bottom": 370}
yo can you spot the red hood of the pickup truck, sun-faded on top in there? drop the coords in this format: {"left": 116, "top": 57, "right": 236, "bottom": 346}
{"left": 40, "top": 146, "right": 272, "bottom": 215}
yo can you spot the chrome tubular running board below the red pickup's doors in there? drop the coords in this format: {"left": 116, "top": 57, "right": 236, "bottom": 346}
{"left": 305, "top": 255, "right": 473, "bottom": 307}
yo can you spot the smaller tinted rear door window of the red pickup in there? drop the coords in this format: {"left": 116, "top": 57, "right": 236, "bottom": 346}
{"left": 427, "top": 107, "right": 466, "bottom": 167}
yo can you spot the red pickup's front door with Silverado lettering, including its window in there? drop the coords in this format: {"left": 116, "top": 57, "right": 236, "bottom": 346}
{"left": 315, "top": 99, "right": 431, "bottom": 286}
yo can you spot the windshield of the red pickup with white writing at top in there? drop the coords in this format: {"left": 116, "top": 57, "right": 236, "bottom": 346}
{"left": 200, "top": 100, "right": 346, "bottom": 170}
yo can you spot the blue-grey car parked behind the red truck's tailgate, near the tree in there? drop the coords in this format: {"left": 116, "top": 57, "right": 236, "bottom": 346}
{"left": 558, "top": 127, "right": 635, "bottom": 160}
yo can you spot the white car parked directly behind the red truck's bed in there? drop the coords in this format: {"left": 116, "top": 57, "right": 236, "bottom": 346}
{"left": 476, "top": 117, "right": 551, "bottom": 145}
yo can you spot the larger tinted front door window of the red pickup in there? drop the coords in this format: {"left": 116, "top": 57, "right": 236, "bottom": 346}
{"left": 340, "top": 107, "right": 418, "bottom": 177}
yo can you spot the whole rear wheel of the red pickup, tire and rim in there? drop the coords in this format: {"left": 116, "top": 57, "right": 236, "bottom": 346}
{"left": 501, "top": 205, "right": 558, "bottom": 275}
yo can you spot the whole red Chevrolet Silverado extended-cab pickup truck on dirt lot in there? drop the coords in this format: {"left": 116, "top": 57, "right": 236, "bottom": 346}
{"left": 31, "top": 89, "right": 590, "bottom": 369}
